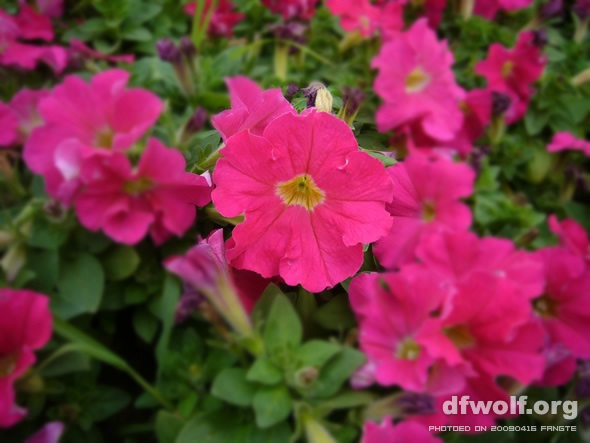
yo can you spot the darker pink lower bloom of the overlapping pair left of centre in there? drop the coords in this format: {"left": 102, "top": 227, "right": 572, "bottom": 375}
{"left": 74, "top": 138, "right": 211, "bottom": 245}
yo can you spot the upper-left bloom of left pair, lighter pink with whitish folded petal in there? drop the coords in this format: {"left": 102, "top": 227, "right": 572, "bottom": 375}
{"left": 24, "top": 69, "right": 162, "bottom": 204}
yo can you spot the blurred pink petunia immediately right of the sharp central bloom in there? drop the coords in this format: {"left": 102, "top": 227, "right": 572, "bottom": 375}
{"left": 373, "top": 152, "right": 475, "bottom": 269}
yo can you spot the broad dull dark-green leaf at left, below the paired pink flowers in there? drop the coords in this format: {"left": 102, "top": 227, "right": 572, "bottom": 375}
{"left": 51, "top": 253, "right": 104, "bottom": 319}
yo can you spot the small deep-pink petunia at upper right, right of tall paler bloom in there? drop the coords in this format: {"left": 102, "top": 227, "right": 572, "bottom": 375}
{"left": 475, "top": 32, "right": 547, "bottom": 123}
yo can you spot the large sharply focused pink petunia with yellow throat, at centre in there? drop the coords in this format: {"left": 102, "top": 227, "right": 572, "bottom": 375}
{"left": 212, "top": 110, "right": 392, "bottom": 292}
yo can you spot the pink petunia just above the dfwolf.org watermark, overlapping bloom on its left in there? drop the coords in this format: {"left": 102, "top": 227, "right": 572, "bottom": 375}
{"left": 421, "top": 271, "right": 545, "bottom": 384}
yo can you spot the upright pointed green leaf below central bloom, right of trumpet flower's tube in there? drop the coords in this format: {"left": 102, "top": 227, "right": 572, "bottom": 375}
{"left": 264, "top": 294, "right": 303, "bottom": 354}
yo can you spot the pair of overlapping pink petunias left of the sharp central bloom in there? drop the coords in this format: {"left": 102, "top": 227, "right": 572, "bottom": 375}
{"left": 24, "top": 69, "right": 211, "bottom": 244}
